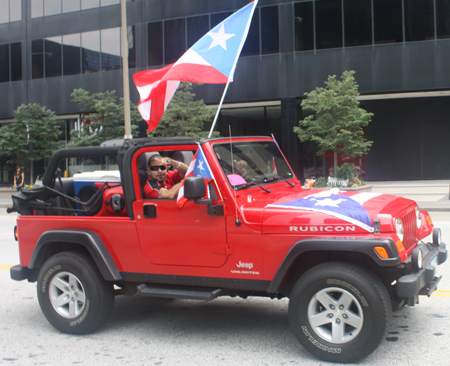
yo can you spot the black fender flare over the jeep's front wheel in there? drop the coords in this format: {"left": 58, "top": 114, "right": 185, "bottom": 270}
{"left": 267, "top": 238, "right": 401, "bottom": 293}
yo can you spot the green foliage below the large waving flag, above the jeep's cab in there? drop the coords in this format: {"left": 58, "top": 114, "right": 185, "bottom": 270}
{"left": 149, "top": 82, "right": 219, "bottom": 138}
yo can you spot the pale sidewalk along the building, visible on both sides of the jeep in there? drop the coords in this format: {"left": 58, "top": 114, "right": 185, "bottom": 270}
{"left": 0, "top": 180, "right": 450, "bottom": 211}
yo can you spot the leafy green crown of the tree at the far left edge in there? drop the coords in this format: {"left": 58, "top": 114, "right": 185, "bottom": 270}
{"left": 0, "top": 104, "right": 61, "bottom": 164}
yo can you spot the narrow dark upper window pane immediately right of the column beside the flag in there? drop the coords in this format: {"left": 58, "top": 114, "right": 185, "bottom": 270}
{"left": 294, "top": 1, "right": 314, "bottom": 51}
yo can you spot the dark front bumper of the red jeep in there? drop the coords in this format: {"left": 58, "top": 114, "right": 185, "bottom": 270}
{"left": 397, "top": 243, "right": 448, "bottom": 297}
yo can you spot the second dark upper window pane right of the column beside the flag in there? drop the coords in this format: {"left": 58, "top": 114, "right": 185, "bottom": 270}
{"left": 315, "top": 0, "right": 342, "bottom": 49}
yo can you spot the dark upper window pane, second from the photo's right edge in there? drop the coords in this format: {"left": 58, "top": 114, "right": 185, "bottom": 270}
{"left": 404, "top": 0, "right": 434, "bottom": 42}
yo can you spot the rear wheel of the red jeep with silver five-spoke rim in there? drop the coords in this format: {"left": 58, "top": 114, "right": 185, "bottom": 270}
{"left": 37, "top": 252, "right": 114, "bottom": 334}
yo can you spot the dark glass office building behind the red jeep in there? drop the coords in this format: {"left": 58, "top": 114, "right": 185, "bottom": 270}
{"left": 0, "top": 0, "right": 450, "bottom": 181}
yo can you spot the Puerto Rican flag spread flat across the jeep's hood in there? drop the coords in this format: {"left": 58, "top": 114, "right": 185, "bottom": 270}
{"left": 268, "top": 188, "right": 381, "bottom": 232}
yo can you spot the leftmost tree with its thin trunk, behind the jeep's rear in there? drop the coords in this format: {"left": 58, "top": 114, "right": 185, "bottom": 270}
{"left": 14, "top": 104, "right": 61, "bottom": 182}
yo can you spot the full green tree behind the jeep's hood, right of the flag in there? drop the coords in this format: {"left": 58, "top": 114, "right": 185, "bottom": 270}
{"left": 294, "top": 71, "right": 373, "bottom": 172}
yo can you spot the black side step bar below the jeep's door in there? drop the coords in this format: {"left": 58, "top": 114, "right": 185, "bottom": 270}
{"left": 137, "top": 283, "right": 222, "bottom": 301}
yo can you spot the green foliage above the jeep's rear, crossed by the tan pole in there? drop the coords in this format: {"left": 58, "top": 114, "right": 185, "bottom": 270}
{"left": 68, "top": 88, "right": 141, "bottom": 146}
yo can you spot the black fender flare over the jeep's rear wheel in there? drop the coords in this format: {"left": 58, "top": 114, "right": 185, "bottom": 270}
{"left": 28, "top": 229, "right": 122, "bottom": 281}
